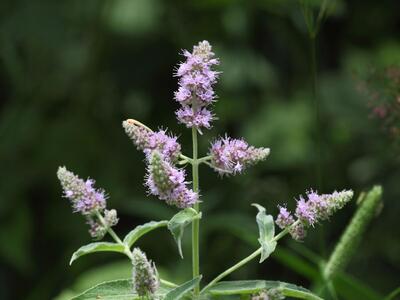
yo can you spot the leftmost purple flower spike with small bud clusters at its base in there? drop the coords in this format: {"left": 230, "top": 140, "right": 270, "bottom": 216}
{"left": 57, "top": 167, "right": 118, "bottom": 239}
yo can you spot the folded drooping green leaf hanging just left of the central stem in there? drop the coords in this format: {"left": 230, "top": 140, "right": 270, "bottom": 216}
{"left": 168, "top": 208, "right": 201, "bottom": 258}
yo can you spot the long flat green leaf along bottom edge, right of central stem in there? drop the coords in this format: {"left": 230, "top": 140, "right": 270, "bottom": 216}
{"left": 207, "top": 280, "right": 322, "bottom": 300}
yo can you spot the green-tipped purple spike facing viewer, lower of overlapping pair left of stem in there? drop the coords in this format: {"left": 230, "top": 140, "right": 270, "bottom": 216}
{"left": 145, "top": 151, "right": 198, "bottom": 208}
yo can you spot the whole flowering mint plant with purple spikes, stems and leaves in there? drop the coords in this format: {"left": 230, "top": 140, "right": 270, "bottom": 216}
{"left": 57, "top": 41, "right": 353, "bottom": 300}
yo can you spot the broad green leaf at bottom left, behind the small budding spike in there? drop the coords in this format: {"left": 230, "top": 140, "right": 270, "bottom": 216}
{"left": 71, "top": 279, "right": 171, "bottom": 300}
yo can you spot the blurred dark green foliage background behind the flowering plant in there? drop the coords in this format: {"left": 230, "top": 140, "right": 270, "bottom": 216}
{"left": 0, "top": 0, "right": 400, "bottom": 300}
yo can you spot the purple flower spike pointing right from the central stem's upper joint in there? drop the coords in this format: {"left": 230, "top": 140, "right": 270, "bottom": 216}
{"left": 209, "top": 137, "right": 270, "bottom": 175}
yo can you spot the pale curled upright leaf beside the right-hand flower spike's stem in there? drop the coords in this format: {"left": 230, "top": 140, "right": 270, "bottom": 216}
{"left": 252, "top": 203, "right": 277, "bottom": 263}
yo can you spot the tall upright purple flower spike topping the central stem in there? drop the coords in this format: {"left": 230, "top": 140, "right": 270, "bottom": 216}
{"left": 175, "top": 41, "right": 219, "bottom": 133}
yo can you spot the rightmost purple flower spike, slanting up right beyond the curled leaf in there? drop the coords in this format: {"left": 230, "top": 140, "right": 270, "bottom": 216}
{"left": 275, "top": 190, "right": 353, "bottom": 240}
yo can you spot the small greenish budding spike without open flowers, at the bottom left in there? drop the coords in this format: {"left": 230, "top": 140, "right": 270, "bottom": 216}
{"left": 132, "top": 248, "right": 160, "bottom": 297}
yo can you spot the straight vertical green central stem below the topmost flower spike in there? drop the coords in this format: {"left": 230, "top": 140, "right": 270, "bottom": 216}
{"left": 192, "top": 127, "right": 200, "bottom": 296}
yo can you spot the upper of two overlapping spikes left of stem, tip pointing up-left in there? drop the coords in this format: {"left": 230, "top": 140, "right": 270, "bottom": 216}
{"left": 122, "top": 119, "right": 181, "bottom": 161}
